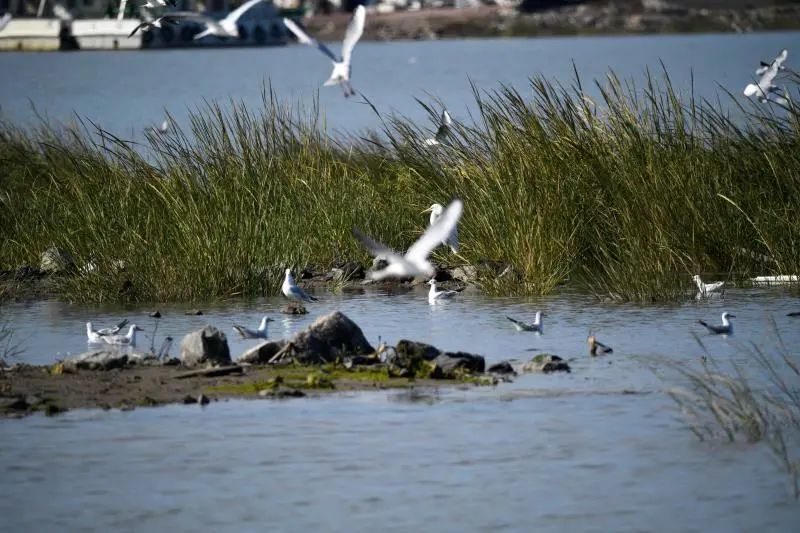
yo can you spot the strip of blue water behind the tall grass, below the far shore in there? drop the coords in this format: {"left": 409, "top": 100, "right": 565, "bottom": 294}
{"left": 0, "top": 32, "right": 800, "bottom": 139}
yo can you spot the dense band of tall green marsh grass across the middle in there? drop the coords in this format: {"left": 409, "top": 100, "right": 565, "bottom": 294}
{"left": 0, "top": 73, "right": 800, "bottom": 301}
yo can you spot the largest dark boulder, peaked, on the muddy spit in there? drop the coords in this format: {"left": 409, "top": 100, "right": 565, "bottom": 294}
{"left": 292, "top": 311, "right": 375, "bottom": 364}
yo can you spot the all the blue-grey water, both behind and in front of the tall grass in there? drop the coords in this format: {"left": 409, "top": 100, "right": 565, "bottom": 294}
{"left": 0, "top": 32, "right": 800, "bottom": 532}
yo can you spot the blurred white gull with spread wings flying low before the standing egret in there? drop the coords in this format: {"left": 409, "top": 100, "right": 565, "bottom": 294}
{"left": 353, "top": 200, "right": 464, "bottom": 281}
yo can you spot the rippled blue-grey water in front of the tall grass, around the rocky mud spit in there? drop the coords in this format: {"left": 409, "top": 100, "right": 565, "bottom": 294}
{"left": 0, "top": 287, "right": 800, "bottom": 531}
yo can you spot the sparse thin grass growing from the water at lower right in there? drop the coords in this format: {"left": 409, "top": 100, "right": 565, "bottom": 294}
{"left": 669, "top": 321, "right": 800, "bottom": 498}
